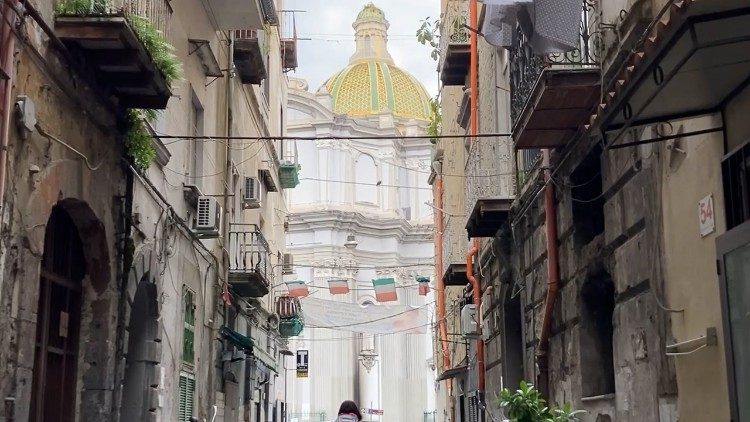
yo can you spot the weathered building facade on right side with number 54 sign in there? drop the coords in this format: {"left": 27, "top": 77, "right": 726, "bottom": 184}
{"left": 438, "top": 1, "right": 749, "bottom": 421}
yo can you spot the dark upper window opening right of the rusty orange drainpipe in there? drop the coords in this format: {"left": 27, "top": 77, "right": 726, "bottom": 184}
{"left": 570, "top": 146, "right": 604, "bottom": 246}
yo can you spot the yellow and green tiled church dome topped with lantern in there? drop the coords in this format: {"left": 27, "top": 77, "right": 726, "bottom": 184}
{"left": 321, "top": 3, "right": 430, "bottom": 120}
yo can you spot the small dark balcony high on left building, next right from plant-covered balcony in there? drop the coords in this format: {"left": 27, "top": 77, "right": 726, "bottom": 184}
{"left": 234, "top": 29, "right": 268, "bottom": 85}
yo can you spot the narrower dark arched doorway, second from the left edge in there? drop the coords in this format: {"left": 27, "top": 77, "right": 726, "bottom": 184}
{"left": 120, "top": 273, "right": 160, "bottom": 421}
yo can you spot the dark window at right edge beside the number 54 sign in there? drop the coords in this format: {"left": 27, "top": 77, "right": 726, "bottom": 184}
{"left": 721, "top": 142, "right": 750, "bottom": 230}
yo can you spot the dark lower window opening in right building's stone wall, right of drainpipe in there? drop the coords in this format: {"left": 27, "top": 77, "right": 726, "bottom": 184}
{"left": 580, "top": 273, "right": 615, "bottom": 397}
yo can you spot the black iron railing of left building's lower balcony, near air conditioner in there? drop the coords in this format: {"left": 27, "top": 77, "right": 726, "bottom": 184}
{"left": 229, "top": 223, "right": 273, "bottom": 284}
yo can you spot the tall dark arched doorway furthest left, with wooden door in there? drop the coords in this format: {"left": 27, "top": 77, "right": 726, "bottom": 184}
{"left": 30, "top": 205, "right": 86, "bottom": 422}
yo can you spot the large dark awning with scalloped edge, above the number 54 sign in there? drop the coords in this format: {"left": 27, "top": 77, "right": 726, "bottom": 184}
{"left": 591, "top": 0, "right": 750, "bottom": 144}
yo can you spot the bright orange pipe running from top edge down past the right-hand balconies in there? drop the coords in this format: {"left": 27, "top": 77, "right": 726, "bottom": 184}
{"left": 466, "top": 0, "right": 484, "bottom": 392}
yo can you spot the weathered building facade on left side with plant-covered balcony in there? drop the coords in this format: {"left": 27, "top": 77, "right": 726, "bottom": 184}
{"left": 0, "top": 1, "right": 296, "bottom": 421}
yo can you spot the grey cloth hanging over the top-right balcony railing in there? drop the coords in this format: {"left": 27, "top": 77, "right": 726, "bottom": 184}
{"left": 482, "top": 0, "right": 583, "bottom": 55}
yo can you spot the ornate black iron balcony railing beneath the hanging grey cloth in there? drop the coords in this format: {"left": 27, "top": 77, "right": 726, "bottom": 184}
{"left": 510, "top": 0, "right": 602, "bottom": 125}
